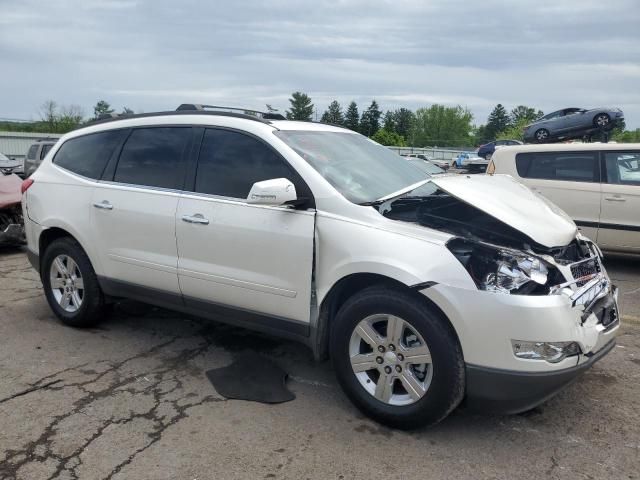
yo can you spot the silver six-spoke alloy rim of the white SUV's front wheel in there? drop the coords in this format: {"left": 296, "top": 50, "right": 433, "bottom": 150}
{"left": 349, "top": 314, "right": 433, "bottom": 406}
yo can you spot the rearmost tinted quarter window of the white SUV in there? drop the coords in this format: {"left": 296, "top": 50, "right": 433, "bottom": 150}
{"left": 53, "top": 130, "right": 126, "bottom": 179}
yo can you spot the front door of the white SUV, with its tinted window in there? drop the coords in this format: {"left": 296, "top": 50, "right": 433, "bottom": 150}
{"left": 176, "top": 128, "right": 315, "bottom": 324}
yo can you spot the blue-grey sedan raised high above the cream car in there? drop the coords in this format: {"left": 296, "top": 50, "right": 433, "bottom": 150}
{"left": 524, "top": 108, "right": 624, "bottom": 143}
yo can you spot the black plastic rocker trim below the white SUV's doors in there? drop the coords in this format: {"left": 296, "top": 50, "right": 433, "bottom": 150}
{"left": 98, "top": 277, "right": 310, "bottom": 344}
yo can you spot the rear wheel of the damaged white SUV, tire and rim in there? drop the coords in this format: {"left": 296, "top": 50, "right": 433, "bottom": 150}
{"left": 40, "top": 237, "right": 107, "bottom": 327}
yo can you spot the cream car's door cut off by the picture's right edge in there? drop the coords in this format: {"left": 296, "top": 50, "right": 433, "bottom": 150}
{"left": 598, "top": 150, "right": 640, "bottom": 253}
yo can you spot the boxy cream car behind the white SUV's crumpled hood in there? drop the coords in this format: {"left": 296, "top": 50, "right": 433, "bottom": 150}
{"left": 488, "top": 143, "right": 640, "bottom": 253}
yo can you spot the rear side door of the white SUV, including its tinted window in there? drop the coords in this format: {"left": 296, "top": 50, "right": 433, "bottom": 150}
{"left": 92, "top": 126, "right": 192, "bottom": 294}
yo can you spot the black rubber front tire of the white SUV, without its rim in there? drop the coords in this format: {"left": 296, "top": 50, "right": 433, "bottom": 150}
{"left": 330, "top": 286, "right": 465, "bottom": 430}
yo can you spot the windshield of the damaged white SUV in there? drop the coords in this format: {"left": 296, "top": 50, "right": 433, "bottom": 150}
{"left": 274, "top": 130, "right": 425, "bottom": 203}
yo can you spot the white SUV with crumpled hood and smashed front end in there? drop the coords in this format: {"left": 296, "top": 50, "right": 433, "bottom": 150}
{"left": 23, "top": 109, "right": 619, "bottom": 428}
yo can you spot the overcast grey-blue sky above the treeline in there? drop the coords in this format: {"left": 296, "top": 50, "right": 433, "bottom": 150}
{"left": 0, "top": 0, "right": 640, "bottom": 128}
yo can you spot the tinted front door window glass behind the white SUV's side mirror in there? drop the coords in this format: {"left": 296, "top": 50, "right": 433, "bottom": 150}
{"left": 195, "top": 129, "right": 300, "bottom": 199}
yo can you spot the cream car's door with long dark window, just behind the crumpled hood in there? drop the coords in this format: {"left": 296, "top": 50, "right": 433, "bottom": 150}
{"left": 516, "top": 151, "right": 601, "bottom": 240}
